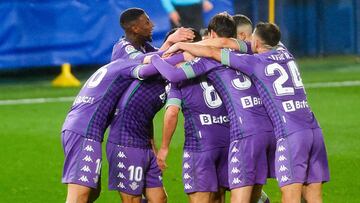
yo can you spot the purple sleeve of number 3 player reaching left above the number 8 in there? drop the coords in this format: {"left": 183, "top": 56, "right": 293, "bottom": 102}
{"left": 152, "top": 56, "right": 221, "bottom": 83}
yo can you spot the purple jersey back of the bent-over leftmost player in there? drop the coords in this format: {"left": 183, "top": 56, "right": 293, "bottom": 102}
{"left": 62, "top": 60, "right": 140, "bottom": 141}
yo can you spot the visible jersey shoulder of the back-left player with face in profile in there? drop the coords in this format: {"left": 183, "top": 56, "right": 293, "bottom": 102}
{"left": 111, "top": 38, "right": 157, "bottom": 61}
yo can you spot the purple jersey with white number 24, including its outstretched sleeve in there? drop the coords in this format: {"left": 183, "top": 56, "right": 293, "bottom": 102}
{"left": 221, "top": 46, "right": 319, "bottom": 138}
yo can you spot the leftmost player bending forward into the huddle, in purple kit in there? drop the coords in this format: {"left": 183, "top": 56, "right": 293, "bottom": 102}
{"left": 62, "top": 54, "right": 184, "bottom": 203}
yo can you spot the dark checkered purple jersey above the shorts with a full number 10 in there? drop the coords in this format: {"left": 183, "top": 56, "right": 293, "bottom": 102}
{"left": 108, "top": 77, "right": 166, "bottom": 148}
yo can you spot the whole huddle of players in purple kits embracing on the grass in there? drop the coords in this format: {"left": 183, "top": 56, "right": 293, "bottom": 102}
{"left": 62, "top": 8, "right": 329, "bottom": 203}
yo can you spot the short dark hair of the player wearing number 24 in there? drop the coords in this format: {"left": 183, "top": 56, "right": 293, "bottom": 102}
{"left": 255, "top": 22, "right": 281, "bottom": 47}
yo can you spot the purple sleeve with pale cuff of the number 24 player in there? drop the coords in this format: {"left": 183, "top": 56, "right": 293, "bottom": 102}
{"left": 221, "top": 49, "right": 258, "bottom": 75}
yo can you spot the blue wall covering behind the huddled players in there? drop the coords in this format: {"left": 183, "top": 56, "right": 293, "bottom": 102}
{"left": 0, "top": 0, "right": 360, "bottom": 70}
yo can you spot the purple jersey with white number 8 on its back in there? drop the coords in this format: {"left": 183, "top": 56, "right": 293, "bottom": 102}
{"left": 166, "top": 77, "right": 229, "bottom": 151}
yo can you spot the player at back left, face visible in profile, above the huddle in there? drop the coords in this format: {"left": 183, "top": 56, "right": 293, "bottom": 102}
{"left": 111, "top": 8, "right": 194, "bottom": 61}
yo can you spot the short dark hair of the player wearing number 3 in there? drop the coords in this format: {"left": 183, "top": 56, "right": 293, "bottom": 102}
{"left": 208, "top": 12, "right": 236, "bottom": 37}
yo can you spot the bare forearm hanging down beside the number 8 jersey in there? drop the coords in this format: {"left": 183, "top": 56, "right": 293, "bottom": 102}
{"left": 157, "top": 106, "right": 180, "bottom": 170}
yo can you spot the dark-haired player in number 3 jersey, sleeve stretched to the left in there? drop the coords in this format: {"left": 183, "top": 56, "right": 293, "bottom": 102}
{"left": 152, "top": 13, "right": 275, "bottom": 202}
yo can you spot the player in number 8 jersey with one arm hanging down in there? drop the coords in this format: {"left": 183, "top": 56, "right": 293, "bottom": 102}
{"left": 157, "top": 31, "right": 229, "bottom": 203}
